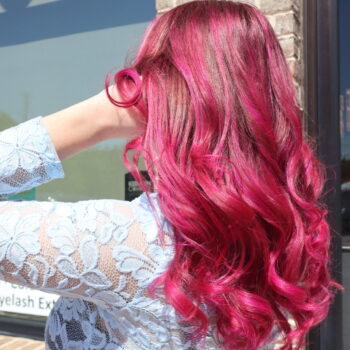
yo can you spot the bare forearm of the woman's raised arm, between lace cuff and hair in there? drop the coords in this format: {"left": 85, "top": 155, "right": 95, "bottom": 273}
{"left": 43, "top": 87, "right": 140, "bottom": 160}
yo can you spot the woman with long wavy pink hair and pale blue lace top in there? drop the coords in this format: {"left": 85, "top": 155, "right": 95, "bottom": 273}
{"left": 0, "top": 1, "right": 340, "bottom": 350}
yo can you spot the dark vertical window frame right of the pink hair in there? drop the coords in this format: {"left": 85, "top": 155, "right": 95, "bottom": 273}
{"left": 303, "top": 0, "right": 343, "bottom": 350}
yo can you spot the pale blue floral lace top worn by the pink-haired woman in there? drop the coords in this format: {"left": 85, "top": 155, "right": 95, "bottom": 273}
{"left": 0, "top": 117, "right": 230, "bottom": 350}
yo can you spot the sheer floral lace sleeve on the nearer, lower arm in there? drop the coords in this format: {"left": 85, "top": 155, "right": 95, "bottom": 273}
{"left": 0, "top": 196, "right": 171, "bottom": 307}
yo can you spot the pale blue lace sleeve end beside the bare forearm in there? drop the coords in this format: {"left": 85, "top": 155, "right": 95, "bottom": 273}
{"left": 0, "top": 117, "right": 64, "bottom": 195}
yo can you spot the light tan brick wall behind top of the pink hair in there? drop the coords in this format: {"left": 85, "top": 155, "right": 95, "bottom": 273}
{"left": 156, "top": 0, "right": 304, "bottom": 108}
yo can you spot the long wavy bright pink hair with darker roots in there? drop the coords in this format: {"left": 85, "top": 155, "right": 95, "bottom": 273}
{"left": 106, "top": 1, "right": 337, "bottom": 349}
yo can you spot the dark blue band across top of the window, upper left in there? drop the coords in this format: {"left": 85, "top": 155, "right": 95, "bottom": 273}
{"left": 0, "top": 0, "right": 156, "bottom": 47}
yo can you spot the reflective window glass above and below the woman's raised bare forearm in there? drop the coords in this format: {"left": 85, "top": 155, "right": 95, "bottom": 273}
{"left": 0, "top": 0, "right": 156, "bottom": 201}
